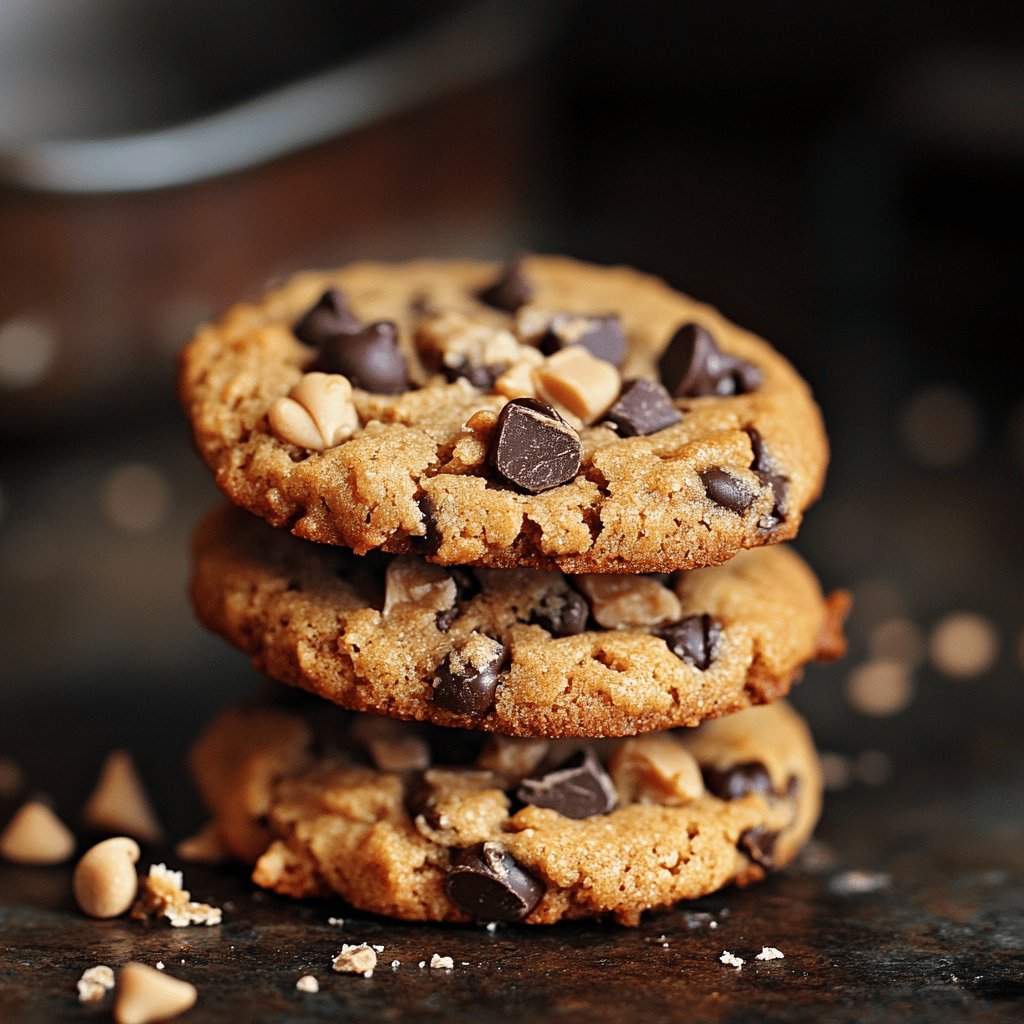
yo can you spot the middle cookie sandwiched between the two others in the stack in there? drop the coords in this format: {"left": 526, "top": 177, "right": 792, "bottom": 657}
{"left": 191, "top": 506, "right": 846, "bottom": 736}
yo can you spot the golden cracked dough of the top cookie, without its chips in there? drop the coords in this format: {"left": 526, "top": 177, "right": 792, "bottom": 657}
{"left": 180, "top": 256, "right": 827, "bottom": 572}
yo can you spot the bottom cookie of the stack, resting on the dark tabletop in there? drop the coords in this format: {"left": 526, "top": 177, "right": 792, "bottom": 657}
{"left": 191, "top": 701, "right": 821, "bottom": 925}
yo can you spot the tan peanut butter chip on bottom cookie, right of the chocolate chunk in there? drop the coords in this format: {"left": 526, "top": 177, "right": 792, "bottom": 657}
{"left": 608, "top": 735, "right": 703, "bottom": 807}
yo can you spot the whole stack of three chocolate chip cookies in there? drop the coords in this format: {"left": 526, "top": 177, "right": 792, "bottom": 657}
{"left": 181, "top": 256, "right": 846, "bottom": 924}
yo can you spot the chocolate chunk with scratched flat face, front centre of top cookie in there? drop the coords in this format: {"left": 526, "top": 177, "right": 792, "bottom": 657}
{"left": 488, "top": 398, "right": 583, "bottom": 495}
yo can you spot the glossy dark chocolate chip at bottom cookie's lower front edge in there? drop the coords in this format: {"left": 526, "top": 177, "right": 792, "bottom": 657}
{"left": 444, "top": 843, "right": 544, "bottom": 922}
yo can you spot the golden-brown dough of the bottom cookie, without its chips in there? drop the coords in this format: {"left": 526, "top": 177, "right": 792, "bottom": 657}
{"left": 191, "top": 701, "right": 821, "bottom": 924}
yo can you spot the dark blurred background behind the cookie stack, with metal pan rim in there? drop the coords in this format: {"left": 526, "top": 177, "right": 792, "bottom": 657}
{"left": 0, "top": 0, "right": 1024, "bottom": 839}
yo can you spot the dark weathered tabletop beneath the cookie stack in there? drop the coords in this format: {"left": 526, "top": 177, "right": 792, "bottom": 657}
{"left": 0, "top": 672, "right": 1024, "bottom": 1024}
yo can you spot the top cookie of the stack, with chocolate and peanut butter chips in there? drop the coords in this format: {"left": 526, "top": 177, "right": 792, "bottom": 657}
{"left": 180, "top": 256, "right": 827, "bottom": 572}
